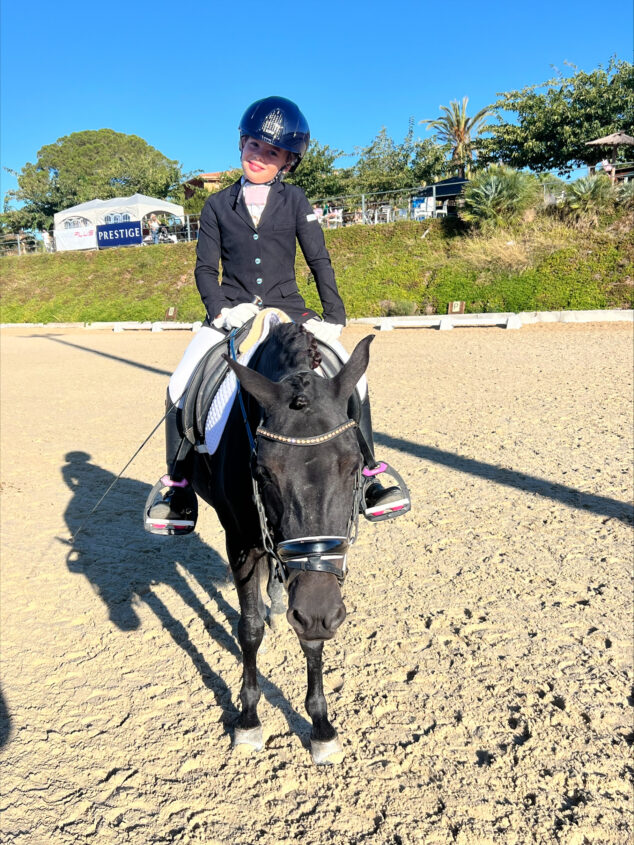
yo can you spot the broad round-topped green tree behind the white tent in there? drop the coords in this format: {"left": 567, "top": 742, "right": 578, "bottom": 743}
{"left": 4, "top": 129, "right": 181, "bottom": 228}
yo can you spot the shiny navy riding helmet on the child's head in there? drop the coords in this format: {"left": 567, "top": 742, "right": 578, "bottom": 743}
{"left": 238, "top": 97, "right": 310, "bottom": 173}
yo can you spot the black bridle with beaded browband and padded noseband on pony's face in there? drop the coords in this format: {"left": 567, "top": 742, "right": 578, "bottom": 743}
{"left": 252, "top": 420, "right": 362, "bottom": 584}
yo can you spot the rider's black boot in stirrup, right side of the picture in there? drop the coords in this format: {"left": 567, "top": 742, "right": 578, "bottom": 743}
{"left": 357, "top": 393, "right": 410, "bottom": 522}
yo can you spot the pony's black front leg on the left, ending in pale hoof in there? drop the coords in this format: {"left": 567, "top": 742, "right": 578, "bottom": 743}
{"left": 232, "top": 549, "right": 264, "bottom": 751}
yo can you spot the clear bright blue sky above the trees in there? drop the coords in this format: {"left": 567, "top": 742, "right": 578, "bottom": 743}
{"left": 1, "top": 0, "right": 632, "bottom": 203}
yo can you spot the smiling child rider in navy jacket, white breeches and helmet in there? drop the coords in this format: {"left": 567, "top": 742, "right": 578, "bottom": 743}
{"left": 146, "top": 97, "right": 409, "bottom": 534}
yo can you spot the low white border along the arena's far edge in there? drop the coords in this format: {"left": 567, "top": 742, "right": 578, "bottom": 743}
{"left": 0, "top": 309, "right": 634, "bottom": 332}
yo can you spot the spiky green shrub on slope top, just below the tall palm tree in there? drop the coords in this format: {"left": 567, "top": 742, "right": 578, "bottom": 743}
{"left": 462, "top": 165, "right": 542, "bottom": 228}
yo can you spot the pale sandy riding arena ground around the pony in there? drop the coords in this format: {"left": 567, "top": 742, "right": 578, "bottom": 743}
{"left": 0, "top": 324, "right": 634, "bottom": 845}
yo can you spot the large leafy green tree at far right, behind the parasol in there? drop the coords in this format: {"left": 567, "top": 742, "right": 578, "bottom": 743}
{"left": 478, "top": 59, "right": 634, "bottom": 174}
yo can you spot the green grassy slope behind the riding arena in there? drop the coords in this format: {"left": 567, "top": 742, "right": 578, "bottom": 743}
{"left": 0, "top": 218, "right": 634, "bottom": 323}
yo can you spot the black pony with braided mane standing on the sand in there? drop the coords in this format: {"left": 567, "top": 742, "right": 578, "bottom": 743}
{"left": 193, "top": 323, "right": 373, "bottom": 763}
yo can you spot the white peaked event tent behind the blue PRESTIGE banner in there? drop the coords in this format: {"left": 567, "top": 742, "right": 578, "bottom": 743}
{"left": 53, "top": 194, "right": 185, "bottom": 252}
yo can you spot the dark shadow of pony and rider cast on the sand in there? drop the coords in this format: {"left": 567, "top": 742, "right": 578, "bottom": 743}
{"left": 62, "top": 451, "right": 310, "bottom": 735}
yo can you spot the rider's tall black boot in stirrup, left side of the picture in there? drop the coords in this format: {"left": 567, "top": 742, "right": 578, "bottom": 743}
{"left": 145, "top": 392, "right": 198, "bottom": 535}
